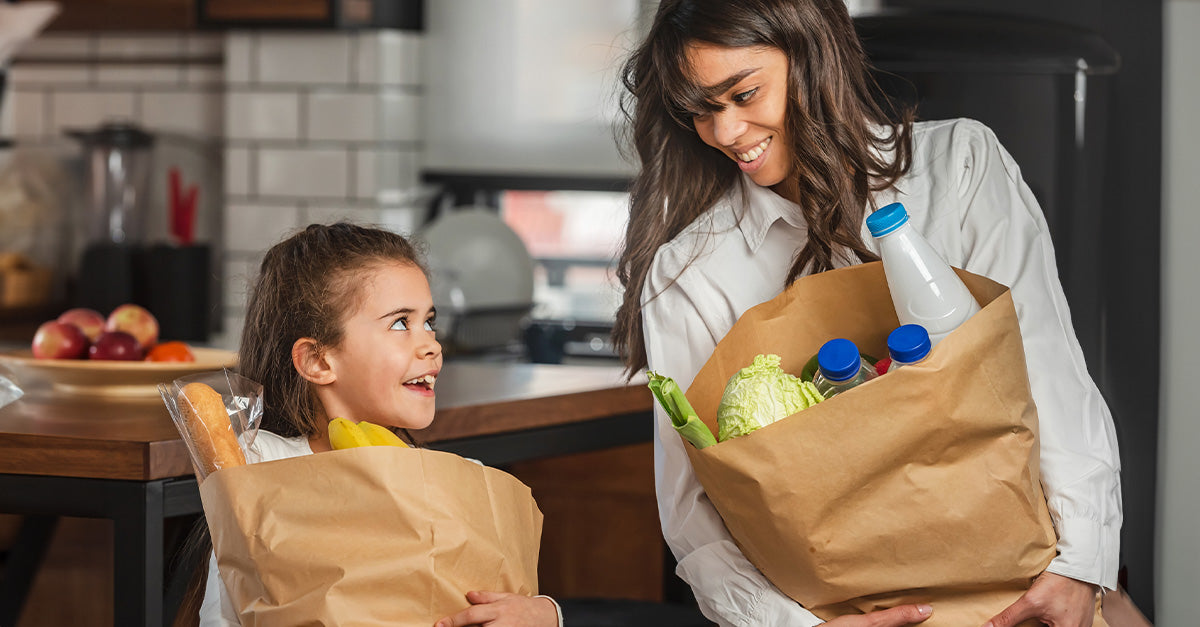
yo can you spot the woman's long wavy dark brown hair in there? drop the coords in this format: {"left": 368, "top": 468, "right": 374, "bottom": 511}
{"left": 613, "top": 0, "right": 913, "bottom": 372}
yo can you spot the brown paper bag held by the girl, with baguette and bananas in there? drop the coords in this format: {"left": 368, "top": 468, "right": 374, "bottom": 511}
{"left": 200, "top": 447, "right": 541, "bottom": 627}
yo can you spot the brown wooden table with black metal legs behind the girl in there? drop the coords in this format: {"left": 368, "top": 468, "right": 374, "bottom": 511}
{"left": 0, "top": 362, "right": 653, "bottom": 627}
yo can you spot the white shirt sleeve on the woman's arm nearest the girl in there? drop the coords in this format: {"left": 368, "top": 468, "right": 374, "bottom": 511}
{"left": 642, "top": 263, "right": 823, "bottom": 627}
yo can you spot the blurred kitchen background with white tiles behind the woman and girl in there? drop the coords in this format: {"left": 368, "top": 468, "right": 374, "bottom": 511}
{"left": 0, "top": 0, "right": 1200, "bottom": 626}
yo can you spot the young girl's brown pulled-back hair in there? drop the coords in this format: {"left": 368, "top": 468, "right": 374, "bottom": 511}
{"left": 238, "top": 222, "right": 428, "bottom": 437}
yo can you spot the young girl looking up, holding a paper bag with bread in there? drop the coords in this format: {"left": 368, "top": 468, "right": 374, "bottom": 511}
{"left": 200, "top": 223, "right": 560, "bottom": 627}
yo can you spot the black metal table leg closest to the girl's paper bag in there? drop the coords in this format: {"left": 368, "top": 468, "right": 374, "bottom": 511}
{"left": 113, "top": 482, "right": 164, "bottom": 627}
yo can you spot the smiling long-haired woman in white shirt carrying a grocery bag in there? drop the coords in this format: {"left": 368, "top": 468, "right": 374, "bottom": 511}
{"left": 614, "top": 0, "right": 1121, "bottom": 627}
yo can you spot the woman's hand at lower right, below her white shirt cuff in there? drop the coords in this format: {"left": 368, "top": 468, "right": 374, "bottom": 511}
{"left": 984, "top": 573, "right": 1096, "bottom": 627}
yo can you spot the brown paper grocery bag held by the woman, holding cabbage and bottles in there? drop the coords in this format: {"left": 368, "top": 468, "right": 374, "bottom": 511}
{"left": 686, "top": 263, "right": 1104, "bottom": 627}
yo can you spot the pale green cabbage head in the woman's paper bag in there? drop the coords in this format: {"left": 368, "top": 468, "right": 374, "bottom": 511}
{"left": 716, "top": 354, "right": 824, "bottom": 442}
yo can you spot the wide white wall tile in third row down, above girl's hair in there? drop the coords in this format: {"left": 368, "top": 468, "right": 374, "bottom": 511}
{"left": 257, "top": 148, "right": 349, "bottom": 198}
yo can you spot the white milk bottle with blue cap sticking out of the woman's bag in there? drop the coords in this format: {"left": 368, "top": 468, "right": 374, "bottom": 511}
{"left": 866, "top": 203, "right": 979, "bottom": 345}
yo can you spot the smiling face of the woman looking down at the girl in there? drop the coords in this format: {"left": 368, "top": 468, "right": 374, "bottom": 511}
{"left": 688, "top": 43, "right": 792, "bottom": 192}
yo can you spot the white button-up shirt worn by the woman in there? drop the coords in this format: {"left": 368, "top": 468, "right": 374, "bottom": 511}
{"left": 642, "top": 120, "right": 1122, "bottom": 627}
